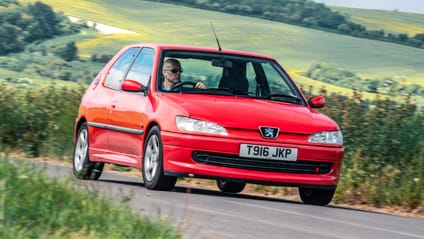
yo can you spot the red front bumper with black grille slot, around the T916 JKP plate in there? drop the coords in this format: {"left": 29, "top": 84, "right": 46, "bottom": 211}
{"left": 161, "top": 131, "right": 344, "bottom": 188}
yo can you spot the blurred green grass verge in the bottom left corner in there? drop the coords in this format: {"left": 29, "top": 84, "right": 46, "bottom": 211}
{"left": 0, "top": 157, "right": 181, "bottom": 239}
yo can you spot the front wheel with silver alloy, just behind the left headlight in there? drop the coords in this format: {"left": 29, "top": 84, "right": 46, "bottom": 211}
{"left": 143, "top": 126, "right": 177, "bottom": 190}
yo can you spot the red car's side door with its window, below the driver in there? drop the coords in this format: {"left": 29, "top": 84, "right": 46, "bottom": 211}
{"left": 109, "top": 48, "right": 154, "bottom": 166}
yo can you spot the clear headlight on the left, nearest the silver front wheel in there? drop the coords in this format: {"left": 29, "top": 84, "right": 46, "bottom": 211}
{"left": 176, "top": 116, "right": 228, "bottom": 135}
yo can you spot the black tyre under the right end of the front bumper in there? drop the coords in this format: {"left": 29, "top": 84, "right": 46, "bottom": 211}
{"left": 299, "top": 188, "right": 336, "bottom": 206}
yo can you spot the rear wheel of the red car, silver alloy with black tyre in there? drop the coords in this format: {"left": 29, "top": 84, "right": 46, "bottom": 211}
{"left": 72, "top": 123, "right": 104, "bottom": 180}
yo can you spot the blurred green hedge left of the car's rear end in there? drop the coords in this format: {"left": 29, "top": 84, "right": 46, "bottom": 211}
{"left": 0, "top": 83, "right": 85, "bottom": 158}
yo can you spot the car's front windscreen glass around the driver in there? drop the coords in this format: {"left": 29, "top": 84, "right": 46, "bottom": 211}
{"left": 159, "top": 51, "right": 305, "bottom": 104}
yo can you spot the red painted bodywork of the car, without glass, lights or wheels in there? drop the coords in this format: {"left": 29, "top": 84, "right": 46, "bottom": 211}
{"left": 76, "top": 44, "right": 344, "bottom": 186}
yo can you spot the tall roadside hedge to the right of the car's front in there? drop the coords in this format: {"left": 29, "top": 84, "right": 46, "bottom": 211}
{"left": 322, "top": 92, "right": 424, "bottom": 208}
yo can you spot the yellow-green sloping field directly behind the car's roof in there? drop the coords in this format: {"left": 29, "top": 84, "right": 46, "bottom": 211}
{"left": 18, "top": 0, "right": 424, "bottom": 90}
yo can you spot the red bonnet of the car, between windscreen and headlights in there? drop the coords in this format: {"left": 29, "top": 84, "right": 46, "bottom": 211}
{"left": 162, "top": 94, "right": 339, "bottom": 134}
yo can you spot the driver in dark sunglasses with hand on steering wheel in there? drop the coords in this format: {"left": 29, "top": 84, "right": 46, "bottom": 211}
{"left": 162, "top": 58, "right": 205, "bottom": 90}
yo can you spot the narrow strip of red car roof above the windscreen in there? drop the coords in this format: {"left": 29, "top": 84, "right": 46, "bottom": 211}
{"left": 127, "top": 43, "right": 274, "bottom": 60}
